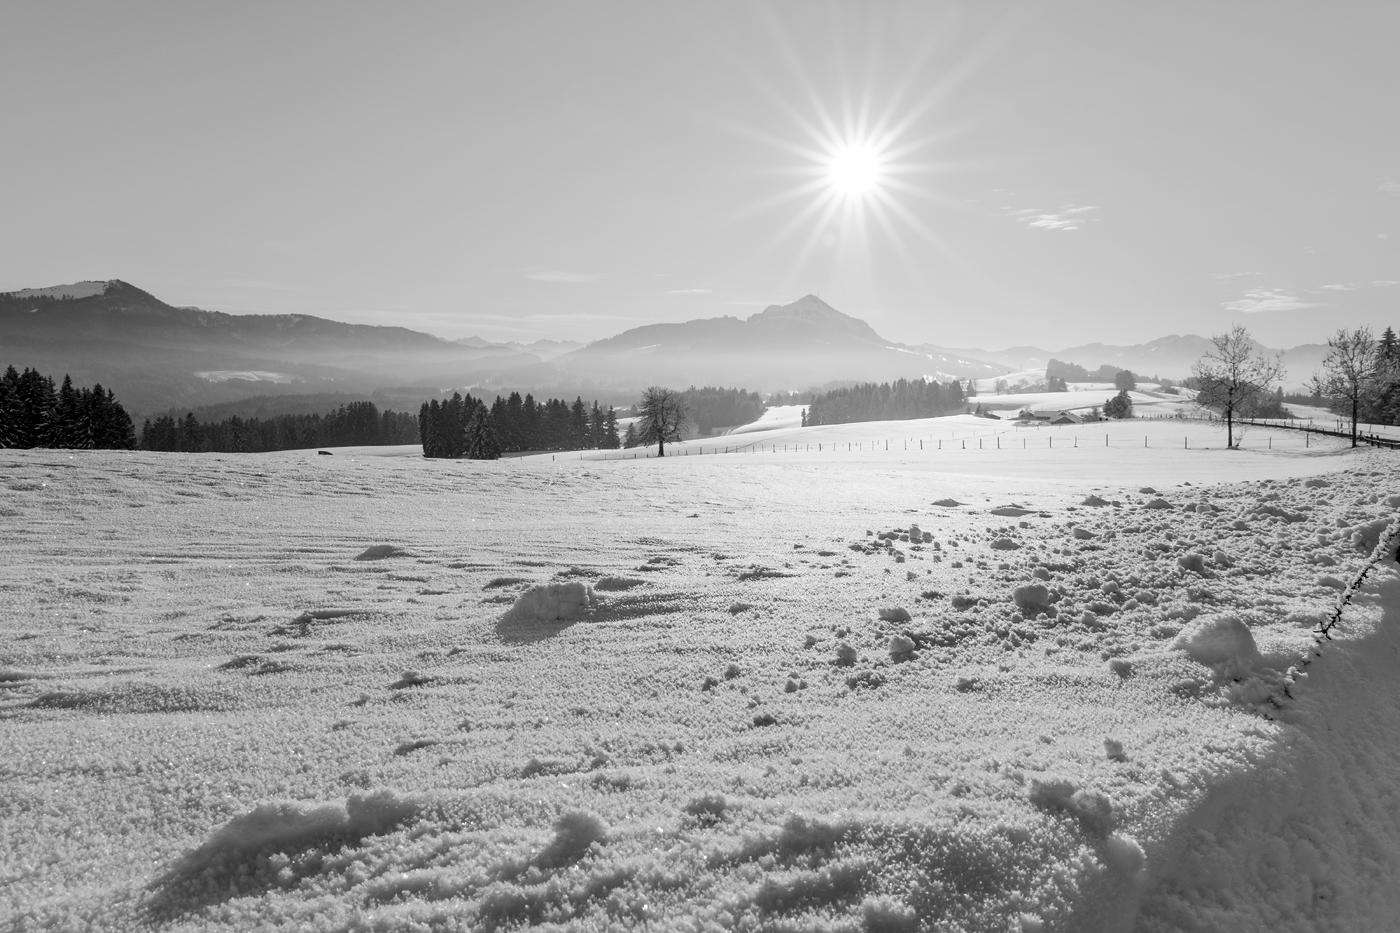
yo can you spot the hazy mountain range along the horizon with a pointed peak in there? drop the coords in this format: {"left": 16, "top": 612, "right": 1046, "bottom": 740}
{"left": 0, "top": 279, "right": 1326, "bottom": 416}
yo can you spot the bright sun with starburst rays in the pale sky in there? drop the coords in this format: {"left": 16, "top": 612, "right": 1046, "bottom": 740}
{"left": 728, "top": 11, "right": 993, "bottom": 282}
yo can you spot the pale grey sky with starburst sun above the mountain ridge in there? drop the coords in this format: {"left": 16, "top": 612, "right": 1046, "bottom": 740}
{"left": 0, "top": 0, "right": 1400, "bottom": 350}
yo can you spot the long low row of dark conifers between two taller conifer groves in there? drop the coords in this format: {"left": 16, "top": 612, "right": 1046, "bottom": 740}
{"left": 141, "top": 402, "right": 419, "bottom": 454}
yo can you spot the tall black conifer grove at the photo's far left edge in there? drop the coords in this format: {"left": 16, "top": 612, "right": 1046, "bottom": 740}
{"left": 0, "top": 366, "right": 136, "bottom": 450}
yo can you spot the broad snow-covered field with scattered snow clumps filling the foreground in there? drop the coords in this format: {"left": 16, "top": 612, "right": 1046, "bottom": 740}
{"left": 0, "top": 413, "right": 1400, "bottom": 933}
